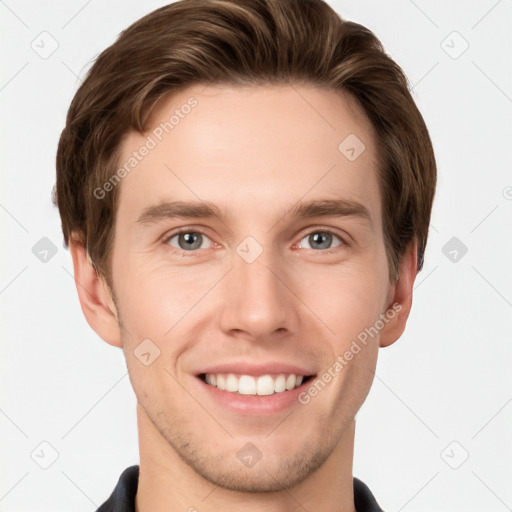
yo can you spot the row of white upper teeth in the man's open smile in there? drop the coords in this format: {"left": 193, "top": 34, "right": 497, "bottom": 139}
{"left": 201, "top": 373, "right": 304, "bottom": 396}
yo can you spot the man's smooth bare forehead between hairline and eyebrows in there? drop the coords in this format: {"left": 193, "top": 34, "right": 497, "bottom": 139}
{"left": 114, "top": 84, "right": 381, "bottom": 227}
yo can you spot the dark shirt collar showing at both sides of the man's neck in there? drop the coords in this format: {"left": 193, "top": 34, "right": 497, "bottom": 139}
{"left": 96, "top": 465, "right": 384, "bottom": 512}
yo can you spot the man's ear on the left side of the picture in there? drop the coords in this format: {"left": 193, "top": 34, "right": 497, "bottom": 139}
{"left": 69, "top": 237, "right": 123, "bottom": 347}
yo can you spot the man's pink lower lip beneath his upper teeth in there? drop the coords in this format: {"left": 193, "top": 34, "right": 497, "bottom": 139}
{"left": 195, "top": 377, "right": 312, "bottom": 415}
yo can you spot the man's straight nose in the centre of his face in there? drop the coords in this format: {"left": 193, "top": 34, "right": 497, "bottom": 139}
{"left": 220, "top": 247, "right": 300, "bottom": 341}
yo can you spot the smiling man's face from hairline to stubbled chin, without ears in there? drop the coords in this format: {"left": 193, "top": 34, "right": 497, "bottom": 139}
{"left": 107, "top": 85, "right": 393, "bottom": 491}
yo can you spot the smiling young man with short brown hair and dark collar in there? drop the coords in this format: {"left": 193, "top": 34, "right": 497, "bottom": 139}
{"left": 56, "top": 0, "right": 436, "bottom": 512}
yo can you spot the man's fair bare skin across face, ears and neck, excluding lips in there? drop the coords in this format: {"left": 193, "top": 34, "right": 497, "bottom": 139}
{"left": 70, "top": 84, "right": 417, "bottom": 512}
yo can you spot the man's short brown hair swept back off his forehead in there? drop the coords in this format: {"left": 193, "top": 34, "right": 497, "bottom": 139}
{"left": 53, "top": 0, "right": 437, "bottom": 284}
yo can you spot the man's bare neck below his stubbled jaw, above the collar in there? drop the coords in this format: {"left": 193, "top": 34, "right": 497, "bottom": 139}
{"left": 135, "top": 404, "right": 356, "bottom": 512}
